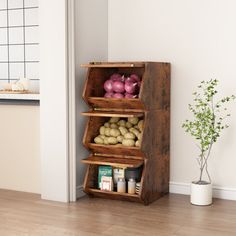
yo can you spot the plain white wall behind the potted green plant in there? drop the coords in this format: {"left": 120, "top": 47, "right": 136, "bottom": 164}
{"left": 108, "top": 0, "right": 236, "bottom": 194}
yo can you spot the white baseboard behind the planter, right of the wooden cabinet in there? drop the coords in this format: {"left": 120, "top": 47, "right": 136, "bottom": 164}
{"left": 170, "top": 182, "right": 236, "bottom": 200}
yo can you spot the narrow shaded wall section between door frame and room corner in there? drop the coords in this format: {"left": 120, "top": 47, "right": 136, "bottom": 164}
{"left": 75, "top": 0, "right": 108, "bottom": 197}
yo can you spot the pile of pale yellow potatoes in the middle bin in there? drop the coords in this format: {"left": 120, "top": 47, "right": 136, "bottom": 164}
{"left": 94, "top": 117, "right": 144, "bottom": 147}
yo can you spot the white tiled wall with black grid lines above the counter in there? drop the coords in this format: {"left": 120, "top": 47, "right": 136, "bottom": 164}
{"left": 0, "top": 0, "right": 39, "bottom": 92}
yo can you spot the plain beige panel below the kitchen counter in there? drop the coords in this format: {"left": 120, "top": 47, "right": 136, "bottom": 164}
{"left": 0, "top": 105, "right": 41, "bottom": 193}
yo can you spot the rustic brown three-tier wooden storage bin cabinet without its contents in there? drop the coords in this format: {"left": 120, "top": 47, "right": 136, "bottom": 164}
{"left": 82, "top": 62, "right": 170, "bottom": 204}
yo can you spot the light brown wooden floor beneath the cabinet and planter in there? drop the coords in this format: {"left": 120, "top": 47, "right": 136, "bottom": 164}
{"left": 0, "top": 190, "right": 236, "bottom": 236}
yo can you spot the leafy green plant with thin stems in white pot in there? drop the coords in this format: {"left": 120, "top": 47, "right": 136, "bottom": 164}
{"left": 182, "top": 79, "right": 235, "bottom": 205}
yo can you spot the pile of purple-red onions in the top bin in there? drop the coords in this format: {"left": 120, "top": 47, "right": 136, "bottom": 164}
{"left": 104, "top": 74, "right": 141, "bottom": 98}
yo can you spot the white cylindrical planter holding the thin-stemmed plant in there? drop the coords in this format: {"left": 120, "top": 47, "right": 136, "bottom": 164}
{"left": 190, "top": 182, "right": 212, "bottom": 206}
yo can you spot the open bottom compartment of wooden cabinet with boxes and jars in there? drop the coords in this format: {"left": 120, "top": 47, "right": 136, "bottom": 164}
{"left": 84, "top": 164, "right": 144, "bottom": 201}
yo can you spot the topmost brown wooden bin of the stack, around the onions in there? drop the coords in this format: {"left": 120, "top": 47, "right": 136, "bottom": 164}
{"left": 83, "top": 62, "right": 171, "bottom": 110}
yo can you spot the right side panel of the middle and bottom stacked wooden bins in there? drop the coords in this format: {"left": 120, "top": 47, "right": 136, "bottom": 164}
{"left": 141, "top": 110, "right": 170, "bottom": 204}
